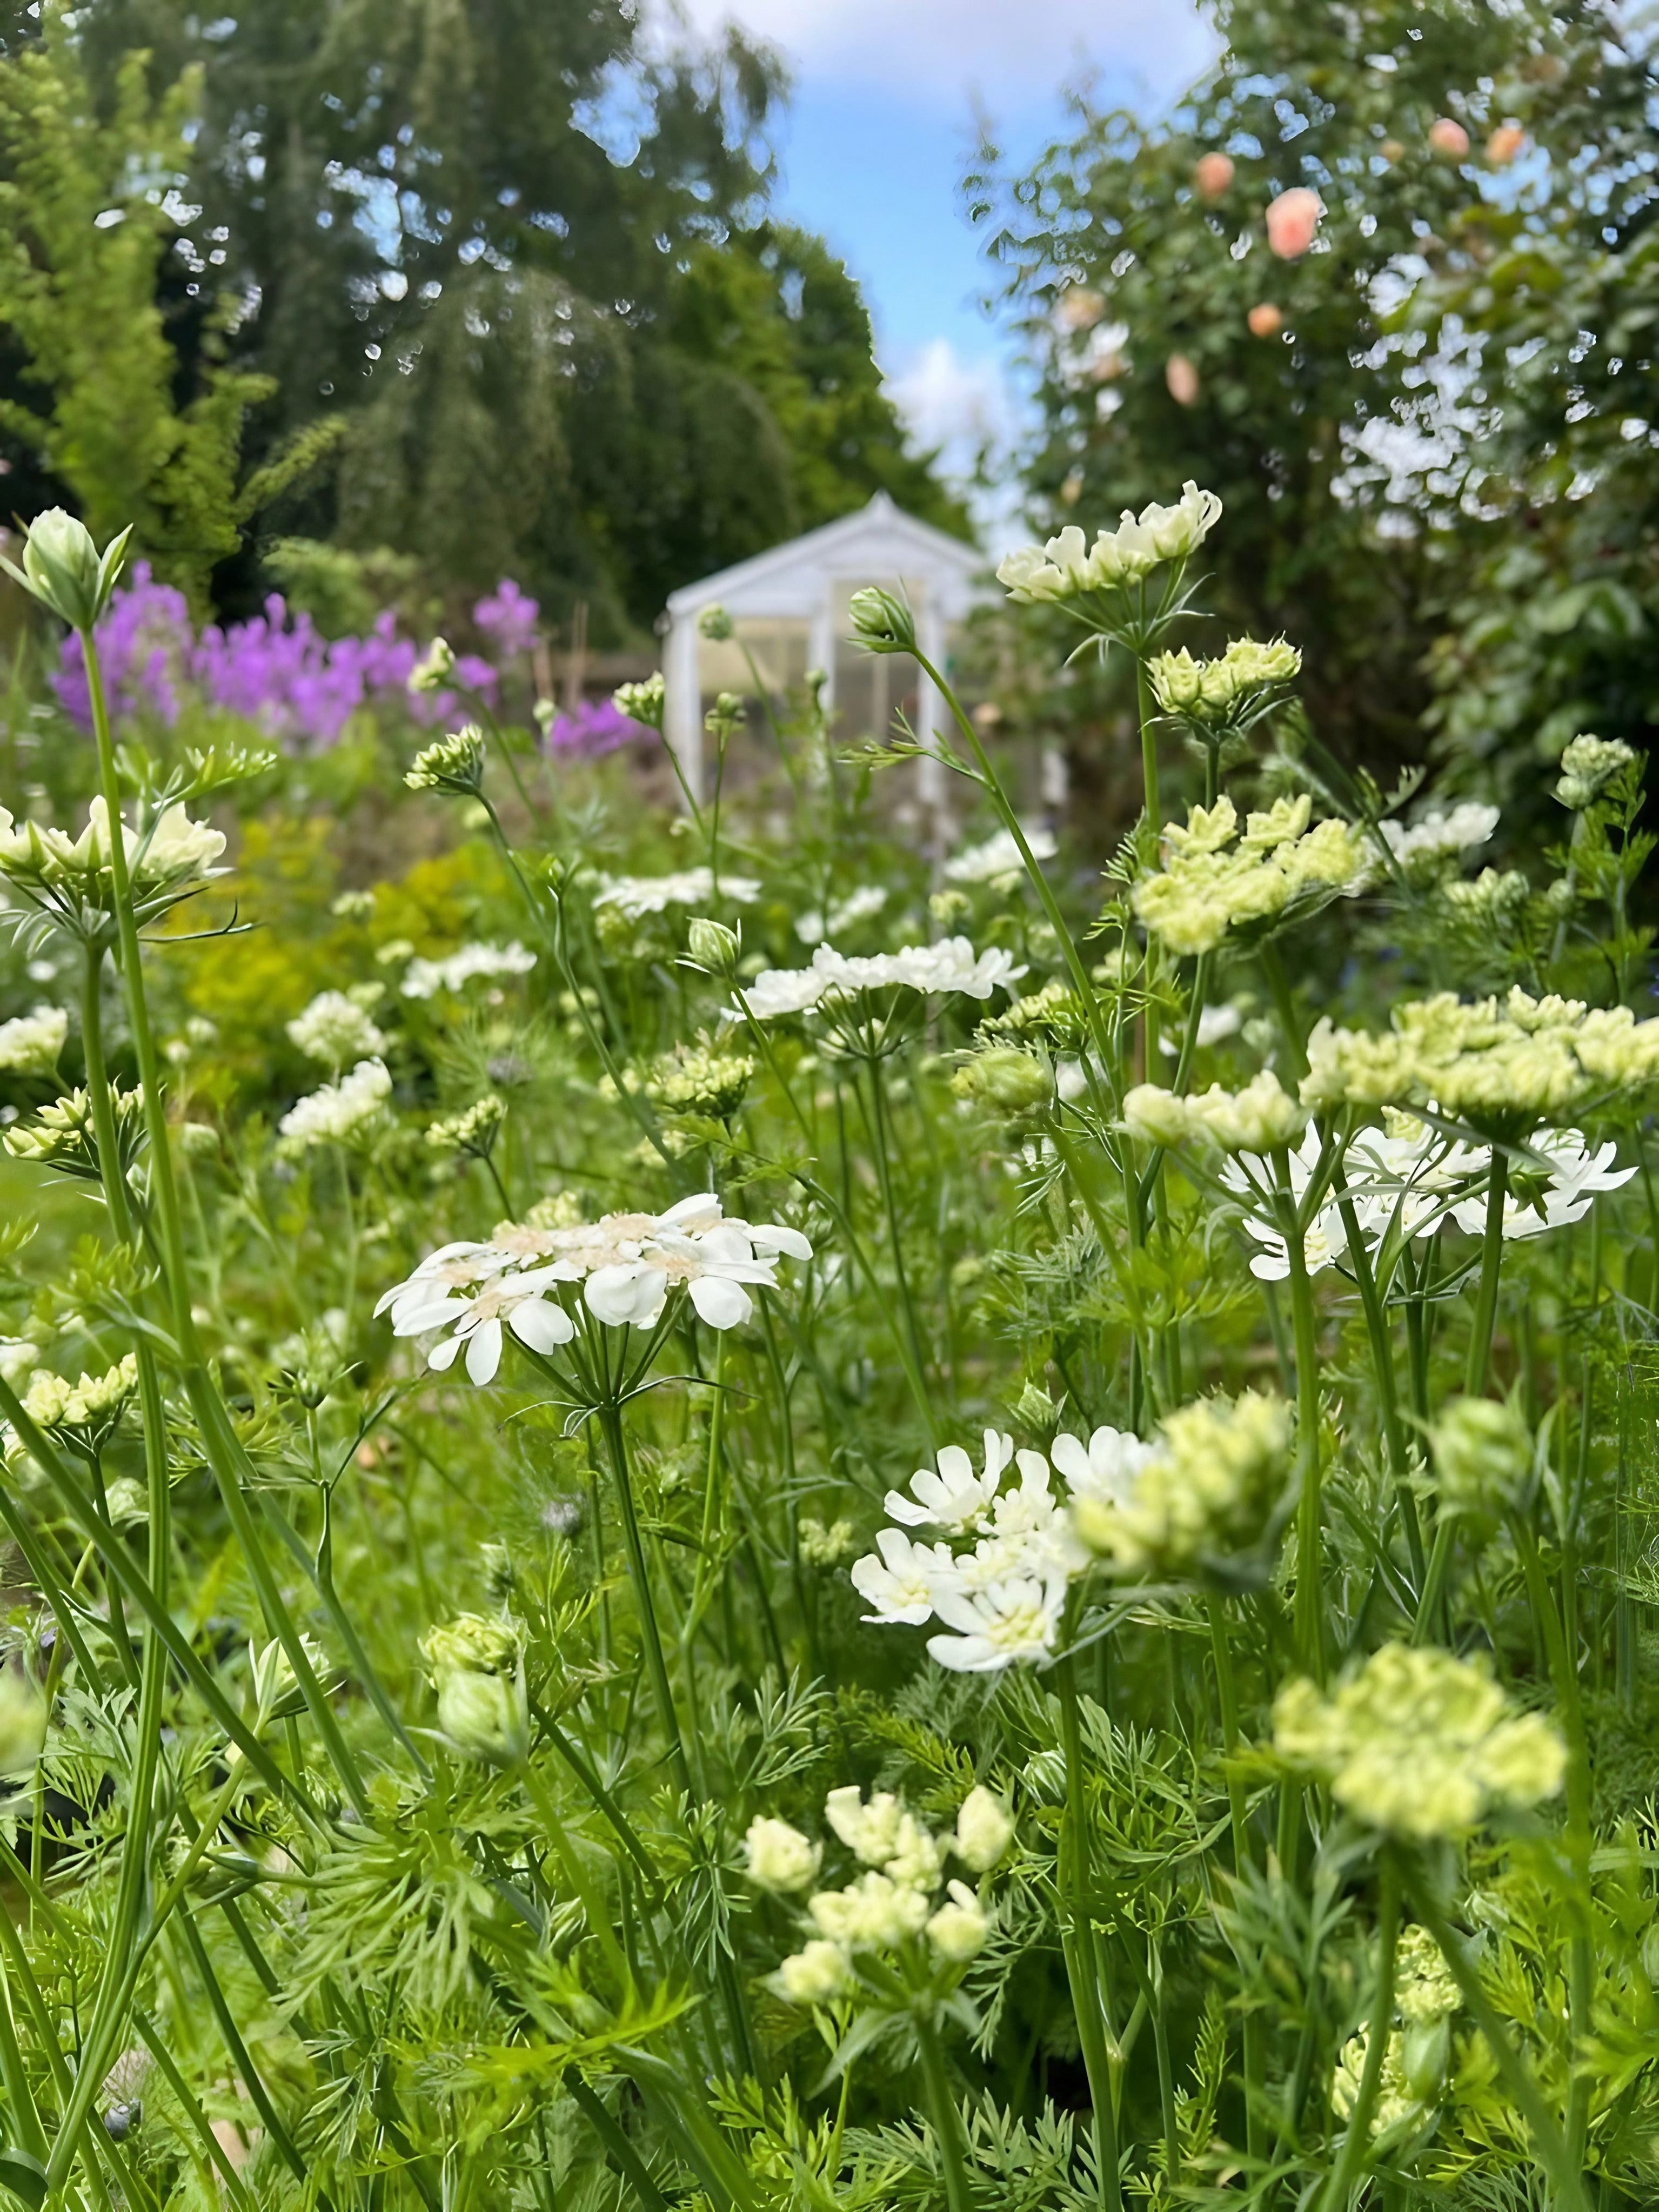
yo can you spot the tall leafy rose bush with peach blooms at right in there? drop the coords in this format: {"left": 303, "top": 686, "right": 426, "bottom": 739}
{"left": 971, "top": 0, "right": 1659, "bottom": 814}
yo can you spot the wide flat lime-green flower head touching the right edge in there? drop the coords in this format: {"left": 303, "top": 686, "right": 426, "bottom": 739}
{"left": 1303, "top": 987, "right": 1659, "bottom": 1128}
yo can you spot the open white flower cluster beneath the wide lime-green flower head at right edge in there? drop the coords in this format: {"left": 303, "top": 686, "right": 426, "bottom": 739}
{"left": 1221, "top": 1108, "right": 1637, "bottom": 1283}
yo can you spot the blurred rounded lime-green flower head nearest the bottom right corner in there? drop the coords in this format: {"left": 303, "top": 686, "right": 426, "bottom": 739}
{"left": 1274, "top": 1644, "right": 1566, "bottom": 1842}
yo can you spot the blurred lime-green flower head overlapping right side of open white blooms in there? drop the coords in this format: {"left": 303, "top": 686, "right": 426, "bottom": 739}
{"left": 1073, "top": 1391, "right": 1289, "bottom": 1579}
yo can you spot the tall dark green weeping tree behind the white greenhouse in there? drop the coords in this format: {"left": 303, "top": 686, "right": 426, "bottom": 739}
{"left": 45, "top": 0, "right": 965, "bottom": 637}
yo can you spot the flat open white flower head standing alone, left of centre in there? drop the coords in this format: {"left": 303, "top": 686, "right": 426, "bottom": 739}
{"left": 374, "top": 1195, "right": 812, "bottom": 1383}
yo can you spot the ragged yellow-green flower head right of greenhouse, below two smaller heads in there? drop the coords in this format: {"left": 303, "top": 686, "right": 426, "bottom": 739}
{"left": 1135, "top": 792, "right": 1369, "bottom": 954}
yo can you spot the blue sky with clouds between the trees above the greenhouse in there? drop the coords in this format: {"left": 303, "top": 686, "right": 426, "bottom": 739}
{"left": 668, "top": 0, "right": 1210, "bottom": 488}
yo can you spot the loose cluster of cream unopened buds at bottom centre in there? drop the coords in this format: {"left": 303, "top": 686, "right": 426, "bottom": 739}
{"left": 743, "top": 1785, "right": 1013, "bottom": 2006}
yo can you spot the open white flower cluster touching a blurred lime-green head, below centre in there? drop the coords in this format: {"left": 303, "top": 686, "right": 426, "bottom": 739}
{"left": 852, "top": 1429, "right": 1153, "bottom": 1674}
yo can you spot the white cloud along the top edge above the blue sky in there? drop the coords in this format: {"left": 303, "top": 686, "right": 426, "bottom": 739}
{"left": 659, "top": 0, "right": 1214, "bottom": 115}
